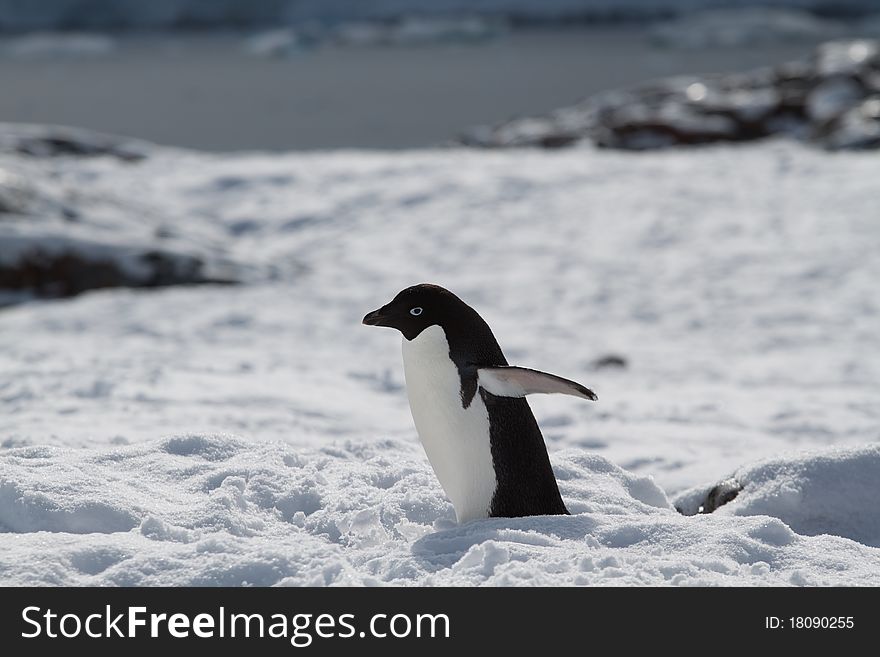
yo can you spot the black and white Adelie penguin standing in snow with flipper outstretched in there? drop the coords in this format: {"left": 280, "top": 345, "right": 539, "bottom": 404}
{"left": 363, "top": 284, "right": 596, "bottom": 522}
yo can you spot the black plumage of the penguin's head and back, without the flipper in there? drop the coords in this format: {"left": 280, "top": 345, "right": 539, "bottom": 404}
{"left": 364, "top": 284, "right": 568, "bottom": 518}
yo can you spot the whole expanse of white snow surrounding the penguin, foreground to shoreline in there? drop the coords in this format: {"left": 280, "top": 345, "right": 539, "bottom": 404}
{"left": 0, "top": 135, "right": 880, "bottom": 586}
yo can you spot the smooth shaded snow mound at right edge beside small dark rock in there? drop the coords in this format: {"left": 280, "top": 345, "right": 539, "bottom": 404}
{"left": 676, "top": 445, "right": 880, "bottom": 547}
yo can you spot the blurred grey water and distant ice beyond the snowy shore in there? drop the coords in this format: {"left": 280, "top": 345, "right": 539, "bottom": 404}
{"left": 0, "top": 0, "right": 880, "bottom": 151}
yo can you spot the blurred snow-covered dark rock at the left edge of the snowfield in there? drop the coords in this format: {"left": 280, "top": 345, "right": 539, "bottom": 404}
{"left": 0, "top": 124, "right": 236, "bottom": 305}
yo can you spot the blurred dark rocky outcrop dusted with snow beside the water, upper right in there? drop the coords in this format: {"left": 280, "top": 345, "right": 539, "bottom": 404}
{"left": 458, "top": 39, "right": 880, "bottom": 150}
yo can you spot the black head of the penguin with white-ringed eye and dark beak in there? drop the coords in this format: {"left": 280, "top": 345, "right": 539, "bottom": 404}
{"left": 363, "top": 283, "right": 470, "bottom": 340}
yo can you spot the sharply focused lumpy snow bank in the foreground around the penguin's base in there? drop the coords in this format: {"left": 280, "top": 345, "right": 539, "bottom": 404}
{"left": 0, "top": 435, "right": 880, "bottom": 585}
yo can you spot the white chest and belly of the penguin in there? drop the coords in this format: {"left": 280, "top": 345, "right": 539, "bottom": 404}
{"left": 403, "top": 326, "right": 497, "bottom": 522}
